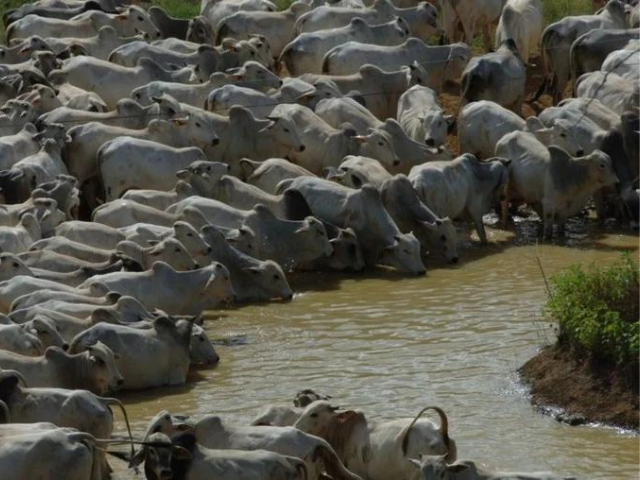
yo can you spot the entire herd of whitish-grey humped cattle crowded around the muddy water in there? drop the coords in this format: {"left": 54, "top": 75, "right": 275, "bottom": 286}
{"left": 0, "top": 0, "right": 640, "bottom": 480}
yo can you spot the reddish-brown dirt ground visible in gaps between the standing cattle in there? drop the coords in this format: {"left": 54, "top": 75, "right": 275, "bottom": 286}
{"left": 438, "top": 57, "right": 553, "bottom": 156}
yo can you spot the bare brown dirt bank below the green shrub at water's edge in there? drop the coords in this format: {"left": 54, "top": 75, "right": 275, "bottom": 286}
{"left": 520, "top": 345, "right": 639, "bottom": 430}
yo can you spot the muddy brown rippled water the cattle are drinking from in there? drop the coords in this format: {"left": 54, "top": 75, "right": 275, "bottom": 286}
{"left": 112, "top": 225, "right": 639, "bottom": 480}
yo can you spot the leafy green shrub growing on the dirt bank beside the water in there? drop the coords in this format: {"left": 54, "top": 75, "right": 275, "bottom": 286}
{"left": 547, "top": 254, "right": 640, "bottom": 371}
